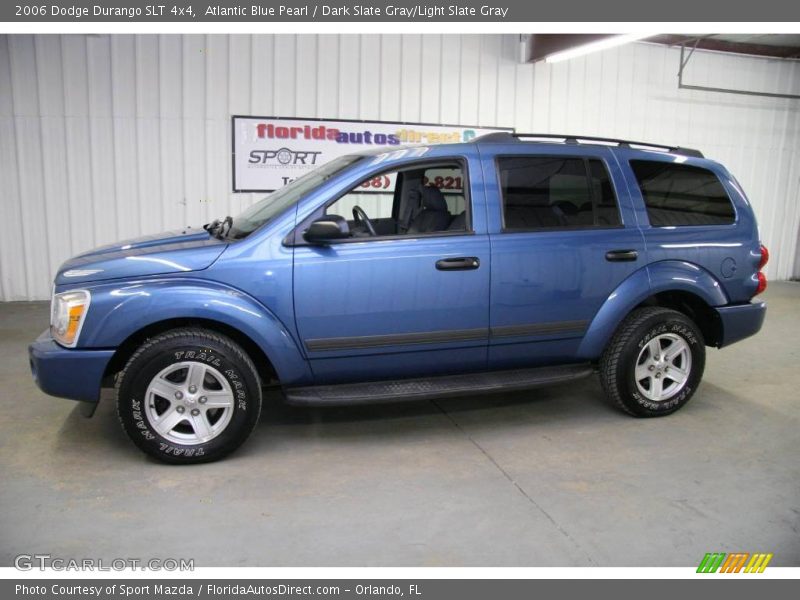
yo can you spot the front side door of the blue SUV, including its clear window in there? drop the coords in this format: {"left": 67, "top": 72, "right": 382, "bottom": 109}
{"left": 294, "top": 157, "right": 491, "bottom": 383}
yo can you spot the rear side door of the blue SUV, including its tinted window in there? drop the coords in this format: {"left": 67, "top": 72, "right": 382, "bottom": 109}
{"left": 481, "top": 143, "right": 646, "bottom": 368}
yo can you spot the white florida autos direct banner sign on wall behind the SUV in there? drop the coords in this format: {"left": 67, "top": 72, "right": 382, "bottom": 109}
{"left": 232, "top": 115, "right": 512, "bottom": 192}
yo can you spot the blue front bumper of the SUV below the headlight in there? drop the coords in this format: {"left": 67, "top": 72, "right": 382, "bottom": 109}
{"left": 28, "top": 331, "right": 114, "bottom": 402}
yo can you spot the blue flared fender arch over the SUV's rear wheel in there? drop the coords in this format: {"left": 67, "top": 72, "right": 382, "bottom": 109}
{"left": 578, "top": 260, "right": 728, "bottom": 360}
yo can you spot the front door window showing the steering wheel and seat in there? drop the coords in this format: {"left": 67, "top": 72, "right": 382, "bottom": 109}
{"left": 325, "top": 161, "right": 468, "bottom": 238}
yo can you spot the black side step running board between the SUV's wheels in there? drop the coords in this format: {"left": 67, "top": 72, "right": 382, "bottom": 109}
{"left": 284, "top": 363, "right": 593, "bottom": 406}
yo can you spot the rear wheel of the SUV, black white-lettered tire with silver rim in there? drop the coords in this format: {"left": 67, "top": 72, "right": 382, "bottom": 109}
{"left": 600, "top": 307, "right": 706, "bottom": 417}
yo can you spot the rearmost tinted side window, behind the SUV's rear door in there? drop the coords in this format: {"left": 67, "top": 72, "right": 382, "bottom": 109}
{"left": 631, "top": 160, "right": 736, "bottom": 227}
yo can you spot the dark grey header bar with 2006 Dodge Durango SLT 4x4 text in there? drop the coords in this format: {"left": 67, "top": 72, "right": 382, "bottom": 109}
{"left": 0, "top": 0, "right": 800, "bottom": 22}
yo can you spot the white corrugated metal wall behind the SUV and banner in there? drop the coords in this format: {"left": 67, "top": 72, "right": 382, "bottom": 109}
{"left": 0, "top": 35, "right": 800, "bottom": 300}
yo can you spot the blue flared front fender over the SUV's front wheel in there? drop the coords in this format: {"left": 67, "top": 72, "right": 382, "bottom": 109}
{"left": 72, "top": 278, "right": 310, "bottom": 384}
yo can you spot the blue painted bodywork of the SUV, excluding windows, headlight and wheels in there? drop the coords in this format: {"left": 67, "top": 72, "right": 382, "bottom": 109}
{"left": 30, "top": 141, "right": 765, "bottom": 401}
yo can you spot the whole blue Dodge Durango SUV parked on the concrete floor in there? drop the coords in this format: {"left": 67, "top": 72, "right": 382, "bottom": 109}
{"left": 30, "top": 133, "right": 768, "bottom": 463}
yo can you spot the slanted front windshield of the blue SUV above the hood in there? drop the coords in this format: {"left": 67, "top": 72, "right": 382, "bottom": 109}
{"left": 228, "top": 155, "right": 364, "bottom": 239}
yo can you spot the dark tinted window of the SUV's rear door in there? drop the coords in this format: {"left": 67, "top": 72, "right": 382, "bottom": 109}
{"left": 498, "top": 156, "right": 620, "bottom": 231}
